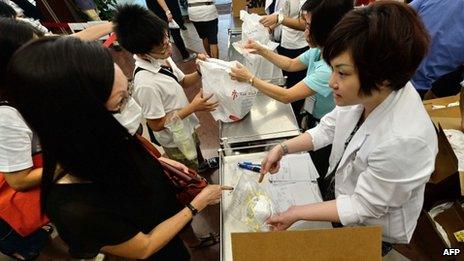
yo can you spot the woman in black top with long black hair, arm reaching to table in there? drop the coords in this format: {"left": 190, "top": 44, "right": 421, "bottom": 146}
{"left": 6, "top": 37, "right": 226, "bottom": 260}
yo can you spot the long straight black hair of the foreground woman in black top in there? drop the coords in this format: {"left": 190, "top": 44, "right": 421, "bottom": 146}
{"left": 6, "top": 37, "right": 159, "bottom": 209}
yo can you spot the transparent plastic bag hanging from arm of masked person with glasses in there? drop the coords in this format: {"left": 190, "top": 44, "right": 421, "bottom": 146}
{"left": 164, "top": 112, "right": 197, "bottom": 160}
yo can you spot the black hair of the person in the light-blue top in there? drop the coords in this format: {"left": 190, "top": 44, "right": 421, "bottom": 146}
{"left": 301, "top": 0, "right": 354, "bottom": 47}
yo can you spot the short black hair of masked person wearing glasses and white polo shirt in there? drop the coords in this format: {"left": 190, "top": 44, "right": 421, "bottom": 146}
{"left": 113, "top": 5, "right": 168, "bottom": 54}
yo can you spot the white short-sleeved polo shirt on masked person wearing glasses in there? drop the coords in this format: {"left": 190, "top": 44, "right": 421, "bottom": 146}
{"left": 132, "top": 55, "right": 200, "bottom": 148}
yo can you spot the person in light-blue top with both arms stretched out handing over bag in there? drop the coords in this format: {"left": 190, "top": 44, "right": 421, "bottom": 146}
{"left": 230, "top": 0, "right": 353, "bottom": 129}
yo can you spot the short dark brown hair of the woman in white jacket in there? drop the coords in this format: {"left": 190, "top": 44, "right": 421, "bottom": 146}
{"left": 323, "top": 1, "right": 430, "bottom": 95}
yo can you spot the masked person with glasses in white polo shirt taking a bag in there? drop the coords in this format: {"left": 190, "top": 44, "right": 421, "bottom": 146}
{"left": 114, "top": 5, "right": 218, "bottom": 173}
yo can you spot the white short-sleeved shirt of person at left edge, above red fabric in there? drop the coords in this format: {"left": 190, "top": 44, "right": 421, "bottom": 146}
{"left": 0, "top": 105, "right": 40, "bottom": 172}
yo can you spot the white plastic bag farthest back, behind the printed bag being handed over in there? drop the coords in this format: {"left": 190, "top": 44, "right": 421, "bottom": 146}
{"left": 237, "top": 10, "right": 283, "bottom": 80}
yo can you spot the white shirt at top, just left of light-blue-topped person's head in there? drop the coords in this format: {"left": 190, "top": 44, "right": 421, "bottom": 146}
{"left": 279, "top": 0, "right": 308, "bottom": 50}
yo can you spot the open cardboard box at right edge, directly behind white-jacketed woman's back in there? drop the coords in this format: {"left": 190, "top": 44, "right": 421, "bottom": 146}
{"left": 424, "top": 95, "right": 464, "bottom": 196}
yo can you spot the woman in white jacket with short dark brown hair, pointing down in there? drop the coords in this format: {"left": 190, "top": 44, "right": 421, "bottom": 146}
{"left": 263, "top": 1, "right": 438, "bottom": 252}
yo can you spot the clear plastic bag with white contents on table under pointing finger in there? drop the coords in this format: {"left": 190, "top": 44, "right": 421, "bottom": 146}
{"left": 226, "top": 168, "right": 276, "bottom": 232}
